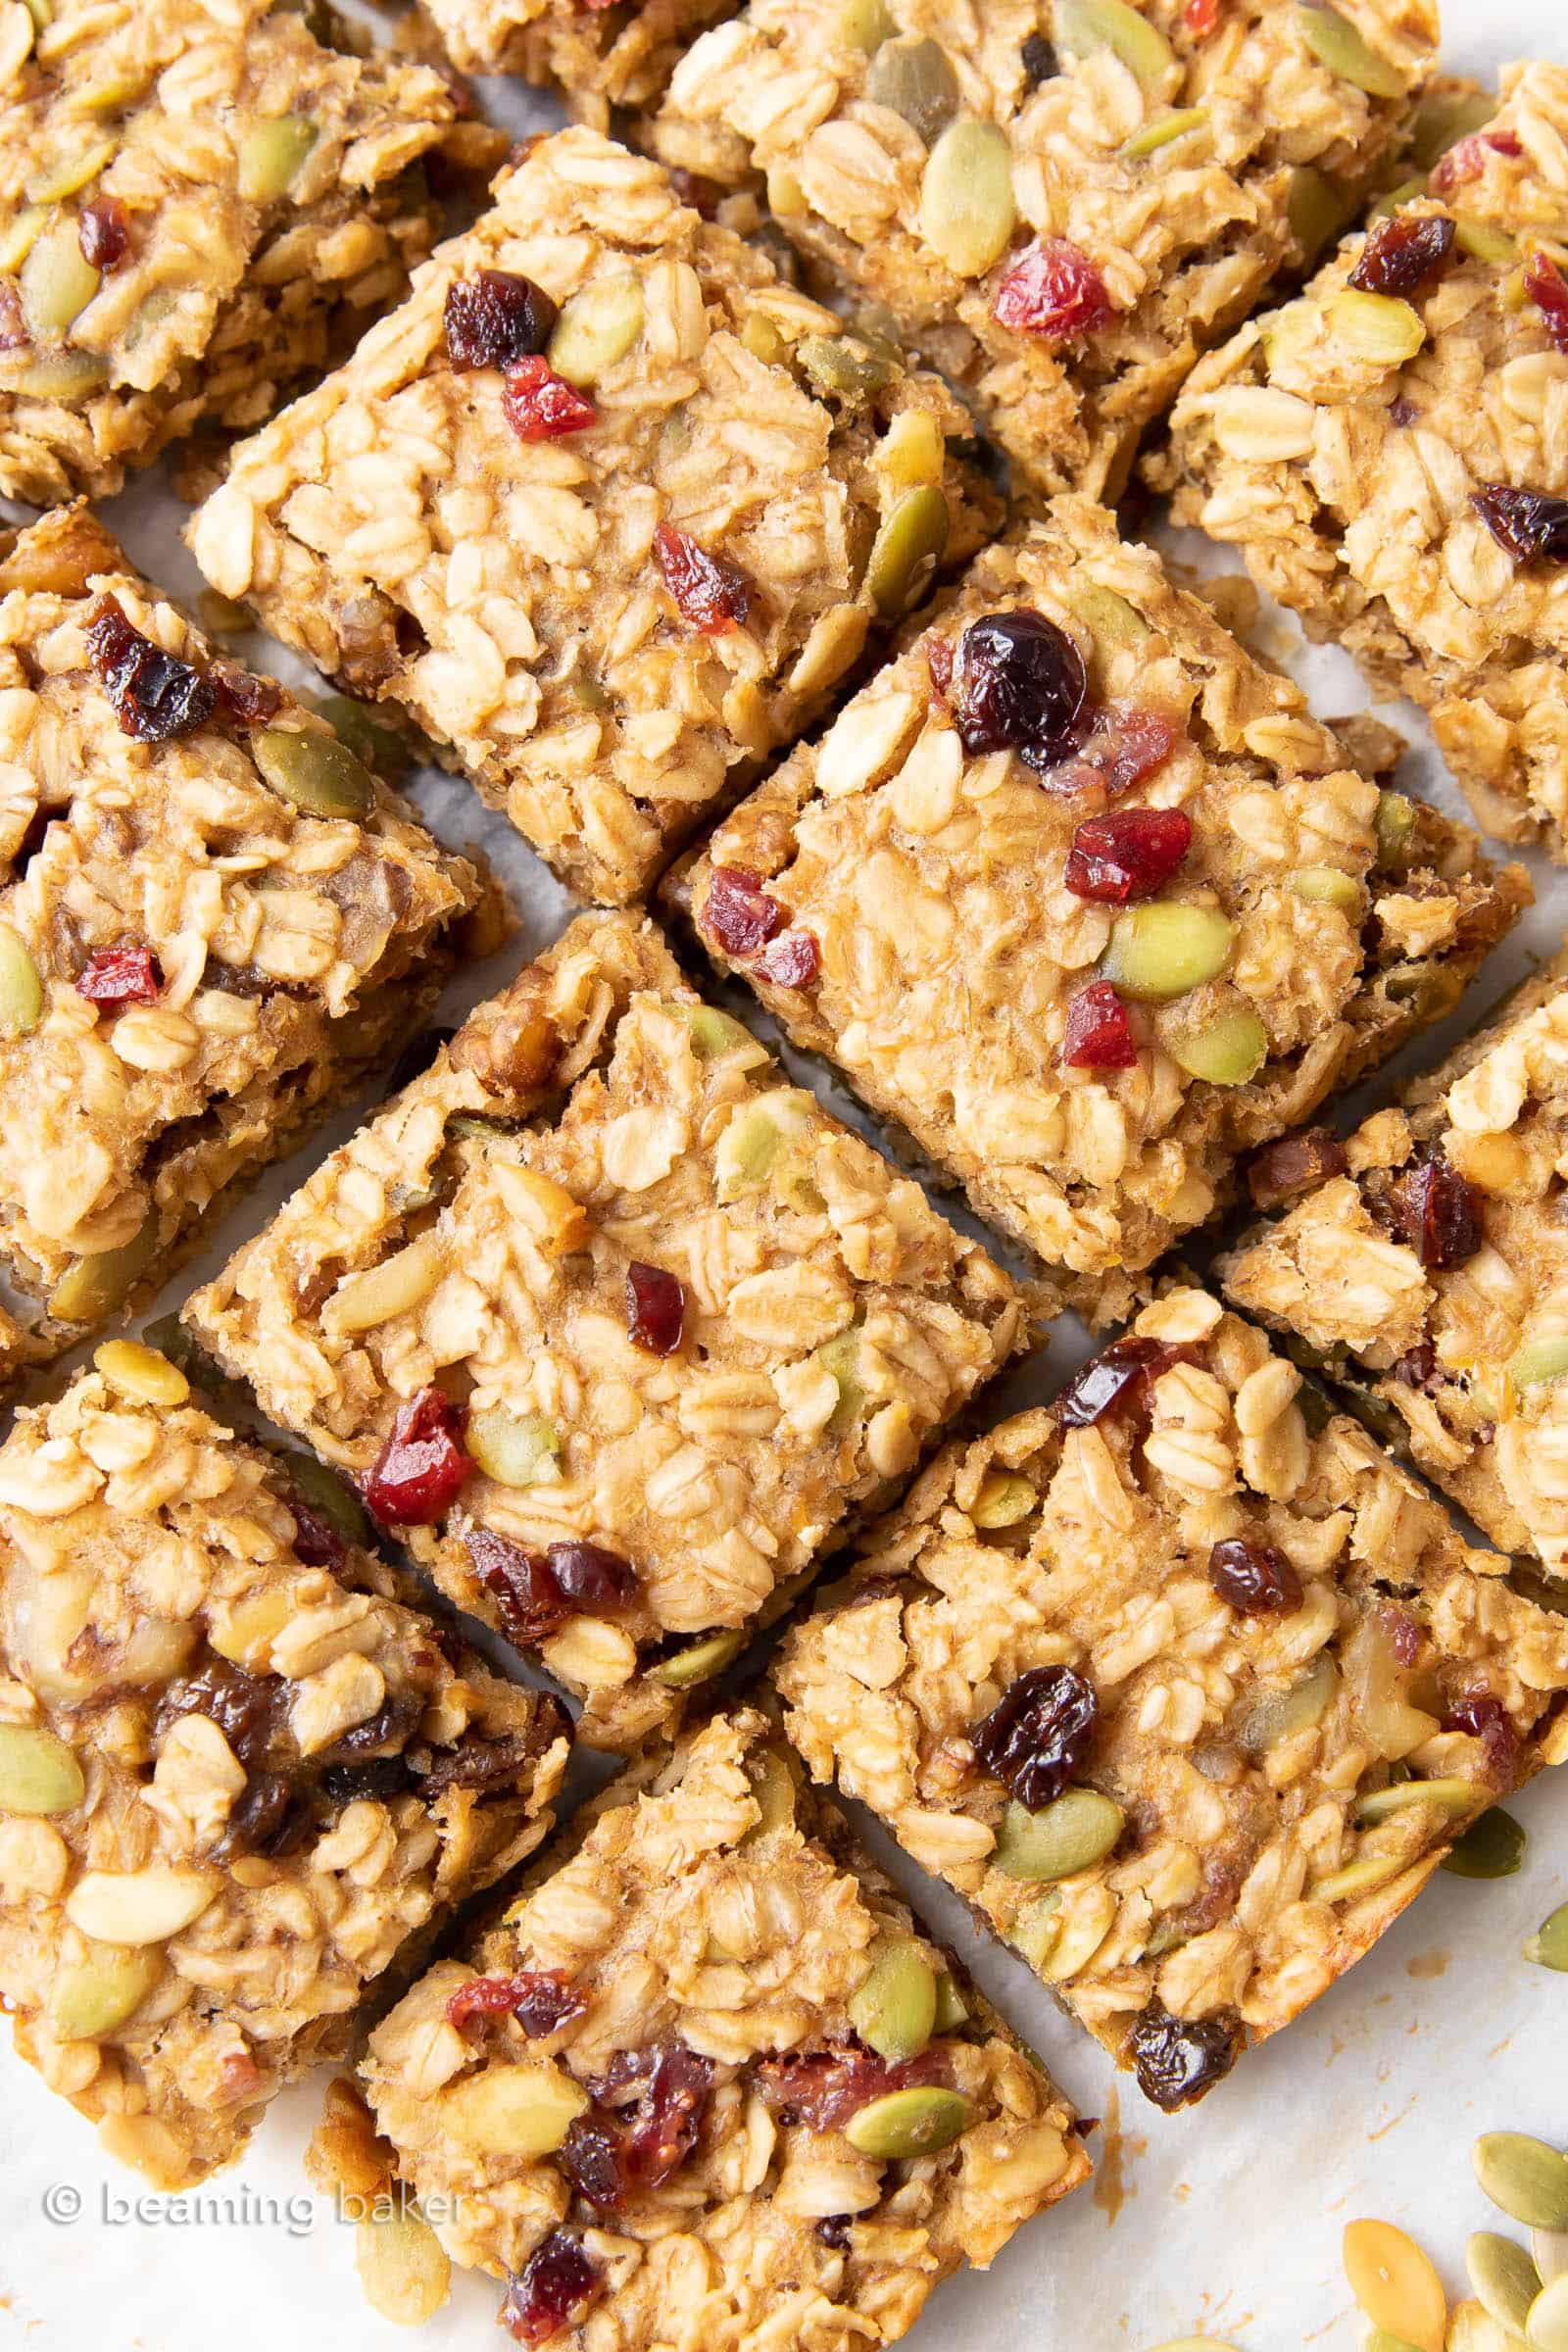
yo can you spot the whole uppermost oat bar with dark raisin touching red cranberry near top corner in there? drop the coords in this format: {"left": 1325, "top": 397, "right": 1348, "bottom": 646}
{"left": 193, "top": 129, "right": 992, "bottom": 904}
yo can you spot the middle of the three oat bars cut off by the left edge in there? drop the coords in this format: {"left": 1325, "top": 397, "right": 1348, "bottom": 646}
{"left": 0, "top": 511, "right": 479, "bottom": 1374}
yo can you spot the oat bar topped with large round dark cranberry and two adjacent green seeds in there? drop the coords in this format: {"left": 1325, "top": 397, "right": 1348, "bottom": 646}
{"left": 670, "top": 499, "right": 1528, "bottom": 1315}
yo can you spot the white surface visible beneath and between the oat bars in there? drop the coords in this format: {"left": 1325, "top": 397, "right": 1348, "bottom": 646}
{"left": 0, "top": 0, "right": 1568, "bottom": 2352}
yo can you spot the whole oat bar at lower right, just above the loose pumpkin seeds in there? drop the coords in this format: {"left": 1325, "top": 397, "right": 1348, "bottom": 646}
{"left": 778, "top": 1289, "right": 1568, "bottom": 2110}
